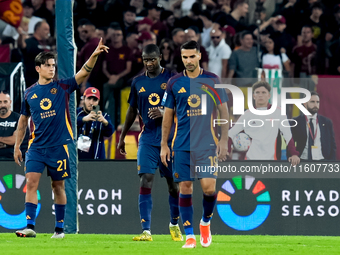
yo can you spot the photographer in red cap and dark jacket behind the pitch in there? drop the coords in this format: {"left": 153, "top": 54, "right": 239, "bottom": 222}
{"left": 77, "top": 87, "right": 114, "bottom": 159}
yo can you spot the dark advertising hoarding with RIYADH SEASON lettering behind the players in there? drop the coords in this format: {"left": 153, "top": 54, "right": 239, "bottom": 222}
{"left": 0, "top": 161, "right": 340, "bottom": 235}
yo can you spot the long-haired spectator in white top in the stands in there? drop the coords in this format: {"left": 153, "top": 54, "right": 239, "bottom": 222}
{"left": 261, "top": 33, "right": 290, "bottom": 72}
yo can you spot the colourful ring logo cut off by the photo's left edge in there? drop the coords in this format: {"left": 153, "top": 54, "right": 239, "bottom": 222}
{"left": 0, "top": 174, "right": 41, "bottom": 229}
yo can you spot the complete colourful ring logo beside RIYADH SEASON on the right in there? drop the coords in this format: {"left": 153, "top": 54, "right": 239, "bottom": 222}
{"left": 217, "top": 175, "right": 270, "bottom": 231}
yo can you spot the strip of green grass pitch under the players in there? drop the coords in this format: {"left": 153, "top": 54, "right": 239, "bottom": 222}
{"left": 0, "top": 233, "right": 340, "bottom": 255}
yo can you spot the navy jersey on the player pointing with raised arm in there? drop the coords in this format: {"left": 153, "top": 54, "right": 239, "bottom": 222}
{"left": 21, "top": 77, "right": 78, "bottom": 148}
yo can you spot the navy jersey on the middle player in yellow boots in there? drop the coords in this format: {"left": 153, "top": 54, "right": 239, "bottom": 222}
{"left": 128, "top": 68, "right": 173, "bottom": 146}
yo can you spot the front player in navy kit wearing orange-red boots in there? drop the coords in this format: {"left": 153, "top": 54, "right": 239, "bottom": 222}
{"left": 161, "top": 41, "right": 229, "bottom": 248}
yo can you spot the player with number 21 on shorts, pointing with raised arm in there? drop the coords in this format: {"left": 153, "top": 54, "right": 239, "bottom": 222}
{"left": 14, "top": 39, "right": 109, "bottom": 238}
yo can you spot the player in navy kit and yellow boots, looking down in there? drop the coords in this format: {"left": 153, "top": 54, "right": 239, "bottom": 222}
{"left": 117, "top": 44, "right": 183, "bottom": 241}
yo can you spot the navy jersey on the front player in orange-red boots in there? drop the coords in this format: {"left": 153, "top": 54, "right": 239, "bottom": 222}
{"left": 162, "top": 69, "right": 228, "bottom": 151}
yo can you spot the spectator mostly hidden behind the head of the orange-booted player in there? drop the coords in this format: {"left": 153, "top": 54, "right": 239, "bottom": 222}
{"left": 174, "top": 27, "right": 209, "bottom": 73}
